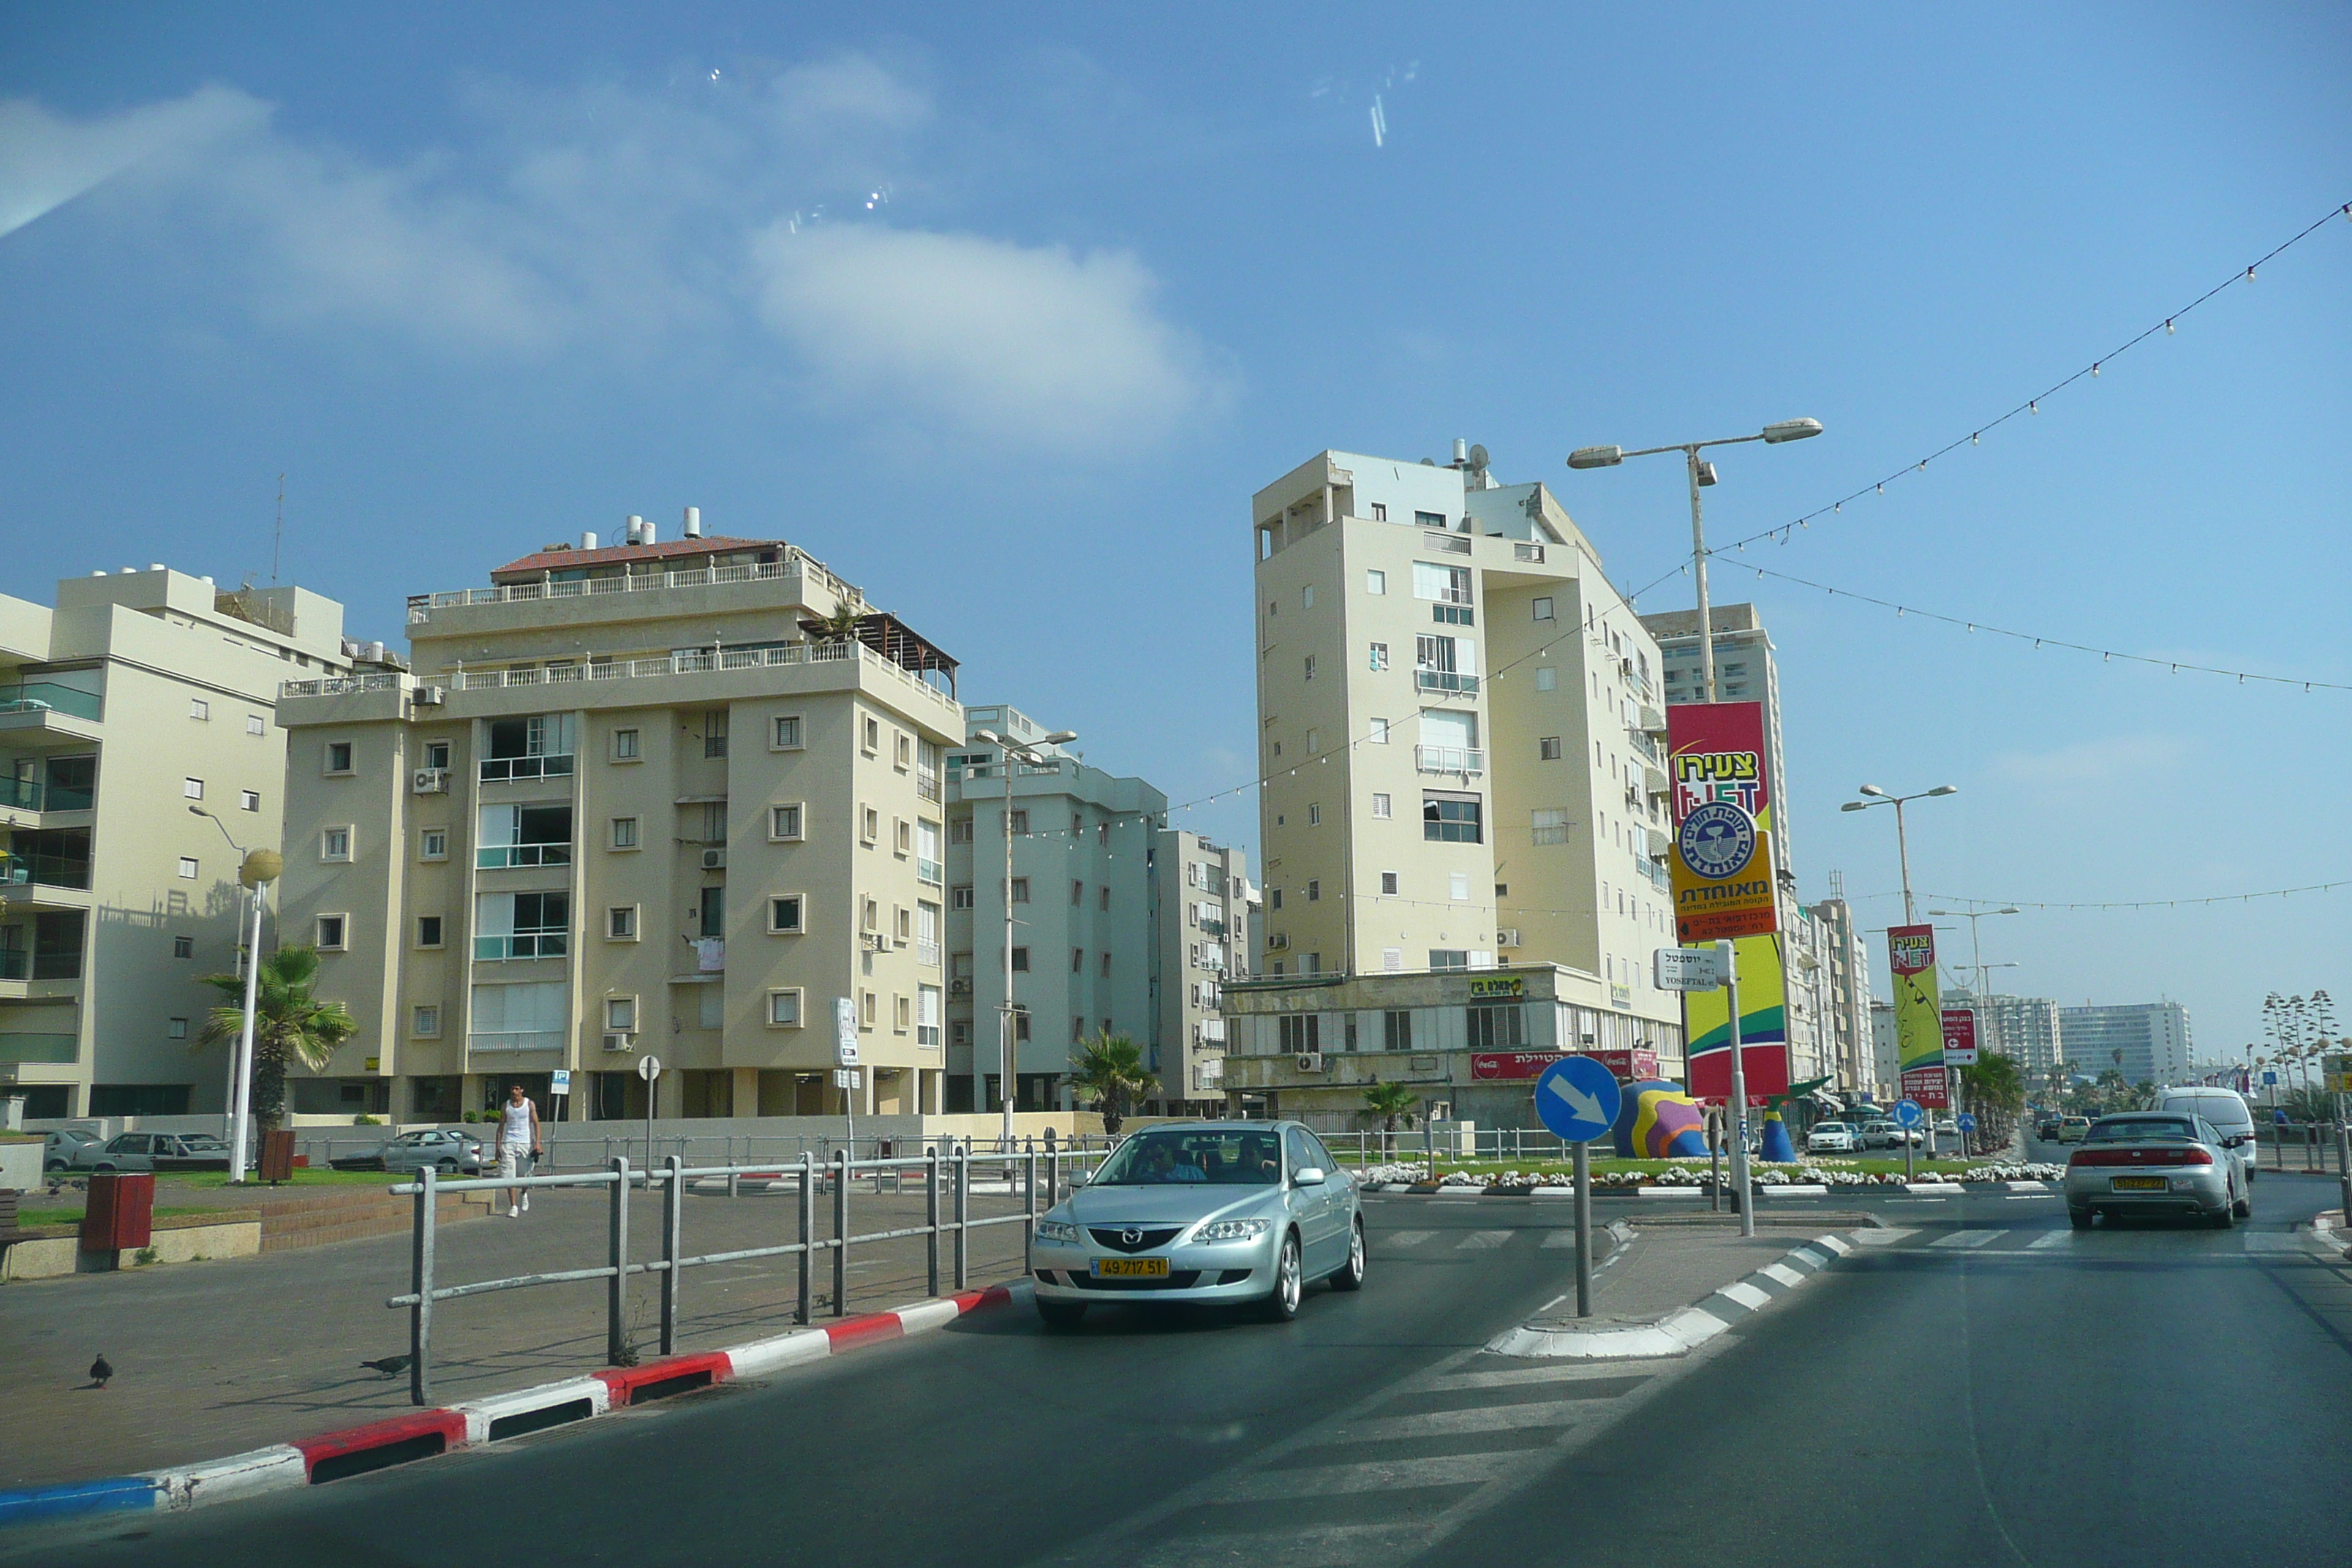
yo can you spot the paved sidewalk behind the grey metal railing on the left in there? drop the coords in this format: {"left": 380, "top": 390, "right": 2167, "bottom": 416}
{"left": 0, "top": 1177, "right": 1023, "bottom": 1485}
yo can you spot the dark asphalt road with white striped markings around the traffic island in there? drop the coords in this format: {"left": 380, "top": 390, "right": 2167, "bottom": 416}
{"left": 0, "top": 1147, "right": 2352, "bottom": 1568}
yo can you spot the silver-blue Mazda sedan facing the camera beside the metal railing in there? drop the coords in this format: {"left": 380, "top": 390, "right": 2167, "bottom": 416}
{"left": 1030, "top": 1121, "right": 1364, "bottom": 1328}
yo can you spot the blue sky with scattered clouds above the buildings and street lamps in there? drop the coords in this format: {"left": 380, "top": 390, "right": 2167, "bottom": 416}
{"left": 0, "top": 0, "right": 2352, "bottom": 1058}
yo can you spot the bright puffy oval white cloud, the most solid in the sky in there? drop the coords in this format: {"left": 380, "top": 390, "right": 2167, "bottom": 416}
{"left": 753, "top": 223, "right": 1213, "bottom": 445}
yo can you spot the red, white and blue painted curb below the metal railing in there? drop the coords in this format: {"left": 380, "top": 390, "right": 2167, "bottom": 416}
{"left": 0, "top": 1281, "right": 1028, "bottom": 1528}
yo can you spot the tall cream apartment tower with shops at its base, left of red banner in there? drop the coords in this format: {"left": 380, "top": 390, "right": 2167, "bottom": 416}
{"left": 1223, "top": 445, "right": 1681, "bottom": 1123}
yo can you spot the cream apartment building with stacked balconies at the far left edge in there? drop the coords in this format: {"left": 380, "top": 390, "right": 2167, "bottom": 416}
{"left": 0, "top": 567, "right": 357, "bottom": 1119}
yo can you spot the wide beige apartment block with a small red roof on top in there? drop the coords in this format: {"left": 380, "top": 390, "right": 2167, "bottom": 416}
{"left": 280, "top": 521, "right": 965, "bottom": 1119}
